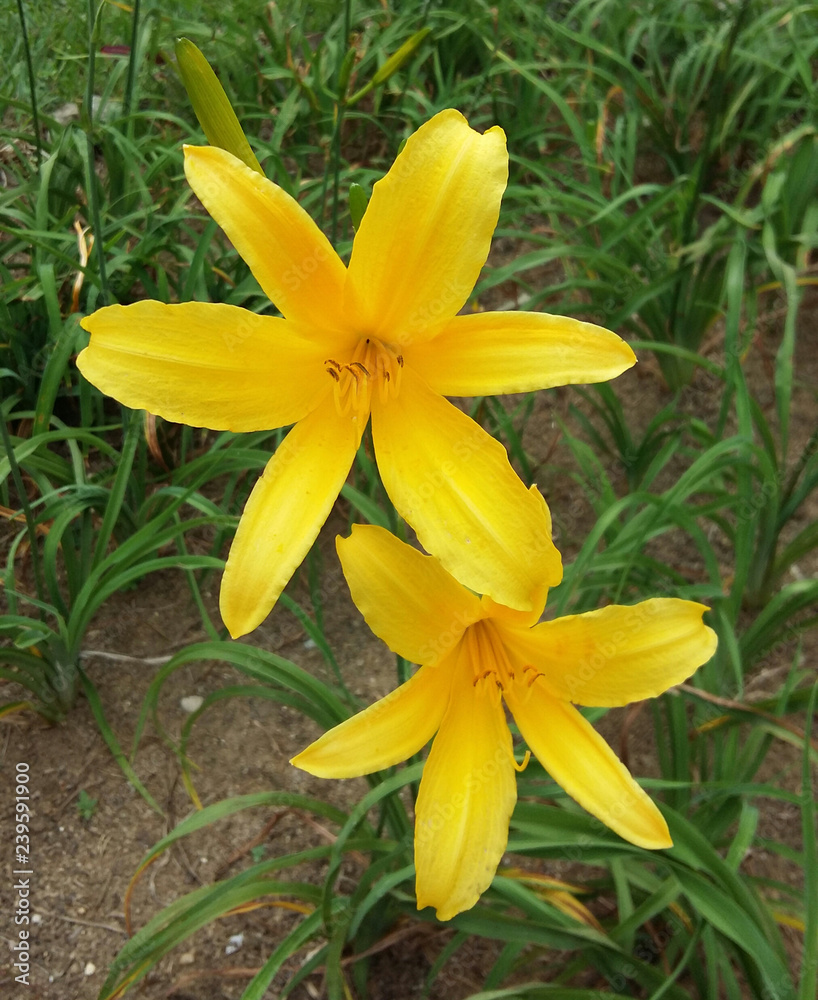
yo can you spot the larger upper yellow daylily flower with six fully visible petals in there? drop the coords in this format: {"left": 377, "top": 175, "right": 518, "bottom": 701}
{"left": 77, "top": 110, "right": 635, "bottom": 637}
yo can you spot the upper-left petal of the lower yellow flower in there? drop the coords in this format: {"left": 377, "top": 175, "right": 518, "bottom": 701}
{"left": 336, "top": 524, "right": 482, "bottom": 664}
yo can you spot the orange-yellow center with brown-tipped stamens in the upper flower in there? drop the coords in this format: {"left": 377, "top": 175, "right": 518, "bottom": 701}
{"left": 324, "top": 337, "right": 403, "bottom": 426}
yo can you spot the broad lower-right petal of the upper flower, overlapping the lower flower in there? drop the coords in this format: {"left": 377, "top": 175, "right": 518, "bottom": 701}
{"left": 372, "top": 367, "right": 562, "bottom": 611}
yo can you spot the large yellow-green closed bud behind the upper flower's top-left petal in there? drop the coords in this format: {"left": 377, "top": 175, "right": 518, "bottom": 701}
{"left": 176, "top": 38, "right": 264, "bottom": 176}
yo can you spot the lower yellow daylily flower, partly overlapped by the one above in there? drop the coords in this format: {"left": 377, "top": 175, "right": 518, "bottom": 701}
{"left": 291, "top": 525, "right": 716, "bottom": 920}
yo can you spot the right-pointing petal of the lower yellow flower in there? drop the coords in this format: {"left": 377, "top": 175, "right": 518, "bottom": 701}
{"left": 503, "top": 598, "right": 716, "bottom": 708}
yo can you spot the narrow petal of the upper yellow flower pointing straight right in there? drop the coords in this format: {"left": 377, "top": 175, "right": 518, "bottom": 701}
{"left": 412, "top": 312, "right": 636, "bottom": 396}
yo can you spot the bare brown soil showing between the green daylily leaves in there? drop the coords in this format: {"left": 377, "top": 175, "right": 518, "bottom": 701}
{"left": 0, "top": 286, "right": 818, "bottom": 1000}
